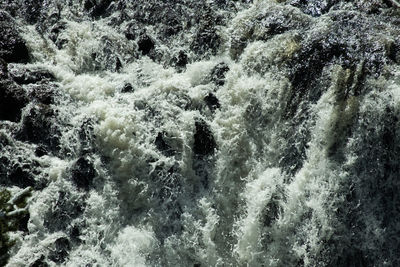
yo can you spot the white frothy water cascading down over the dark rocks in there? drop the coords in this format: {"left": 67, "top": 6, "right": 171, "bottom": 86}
{"left": 5, "top": 1, "right": 400, "bottom": 266}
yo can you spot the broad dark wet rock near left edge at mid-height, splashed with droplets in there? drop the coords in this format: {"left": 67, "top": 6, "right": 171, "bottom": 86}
{"left": 16, "top": 104, "right": 60, "bottom": 152}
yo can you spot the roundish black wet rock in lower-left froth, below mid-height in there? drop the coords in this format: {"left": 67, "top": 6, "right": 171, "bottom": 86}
{"left": 71, "top": 157, "right": 96, "bottom": 191}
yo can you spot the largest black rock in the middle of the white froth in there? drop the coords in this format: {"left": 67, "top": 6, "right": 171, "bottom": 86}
{"left": 193, "top": 119, "right": 217, "bottom": 157}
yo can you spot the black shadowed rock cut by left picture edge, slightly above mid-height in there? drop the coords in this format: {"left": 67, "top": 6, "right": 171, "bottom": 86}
{"left": 0, "top": 81, "right": 28, "bottom": 122}
